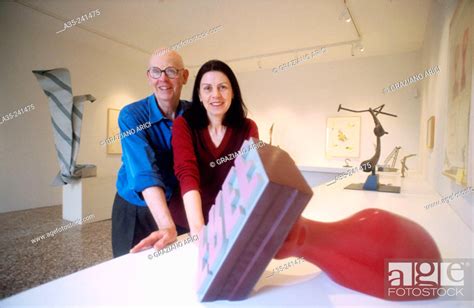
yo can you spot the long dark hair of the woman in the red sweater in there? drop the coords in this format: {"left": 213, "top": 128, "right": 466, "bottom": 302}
{"left": 183, "top": 60, "right": 247, "bottom": 129}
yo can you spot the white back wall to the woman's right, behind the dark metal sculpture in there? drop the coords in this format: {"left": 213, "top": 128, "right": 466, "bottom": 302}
{"left": 233, "top": 49, "right": 422, "bottom": 170}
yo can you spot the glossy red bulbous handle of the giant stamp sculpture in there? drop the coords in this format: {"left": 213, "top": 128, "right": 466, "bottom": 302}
{"left": 275, "top": 209, "right": 441, "bottom": 300}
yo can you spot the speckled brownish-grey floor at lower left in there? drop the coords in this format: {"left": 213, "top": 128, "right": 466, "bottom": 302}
{"left": 0, "top": 205, "right": 112, "bottom": 299}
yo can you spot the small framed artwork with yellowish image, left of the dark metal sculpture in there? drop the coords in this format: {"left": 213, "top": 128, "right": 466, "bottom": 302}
{"left": 326, "top": 117, "right": 360, "bottom": 158}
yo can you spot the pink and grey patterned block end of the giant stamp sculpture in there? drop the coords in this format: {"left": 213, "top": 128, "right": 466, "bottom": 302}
{"left": 198, "top": 139, "right": 312, "bottom": 301}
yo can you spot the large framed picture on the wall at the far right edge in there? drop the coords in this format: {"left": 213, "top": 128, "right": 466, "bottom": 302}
{"left": 443, "top": 0, "right": 474, "bottom": 185}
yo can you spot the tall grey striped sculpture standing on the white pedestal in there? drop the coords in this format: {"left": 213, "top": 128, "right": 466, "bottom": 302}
{"left": 33, "top": 68, "right": 97, "bottom": 186}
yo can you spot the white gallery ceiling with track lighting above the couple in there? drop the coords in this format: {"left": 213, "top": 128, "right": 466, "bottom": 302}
{"left": 15, "top": 0, "right": 434, "bottom": 71}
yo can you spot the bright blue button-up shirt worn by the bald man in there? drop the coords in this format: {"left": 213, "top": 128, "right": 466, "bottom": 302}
{"left": 117, "top": 94, "right": 190, "bottom": 206}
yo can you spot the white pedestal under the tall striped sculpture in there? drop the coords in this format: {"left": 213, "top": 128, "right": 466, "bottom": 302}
{"left": 63, "top": 176, "right": 117, "bottom": 224}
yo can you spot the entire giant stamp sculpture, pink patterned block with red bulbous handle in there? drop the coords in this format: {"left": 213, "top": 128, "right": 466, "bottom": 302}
{"left": 197, "top": 139, "right": 442, "bottom": 302}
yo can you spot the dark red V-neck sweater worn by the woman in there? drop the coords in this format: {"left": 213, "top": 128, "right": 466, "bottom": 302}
{"left": 169, "top": 117, "right": 258, "bottom": 228}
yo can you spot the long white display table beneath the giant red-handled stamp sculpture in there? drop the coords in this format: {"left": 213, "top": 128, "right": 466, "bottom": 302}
{"left": 0, "top": 172, "right": 474, "bottom": 308}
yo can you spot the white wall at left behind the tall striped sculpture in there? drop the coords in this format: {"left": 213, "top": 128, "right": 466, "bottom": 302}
{"left": 0, "top": 2, "right": 150, "bottom": 212}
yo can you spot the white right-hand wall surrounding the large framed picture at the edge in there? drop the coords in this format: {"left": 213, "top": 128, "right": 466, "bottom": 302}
{"left": 420, "top": 1, "right": 474, "bottom": 229}
